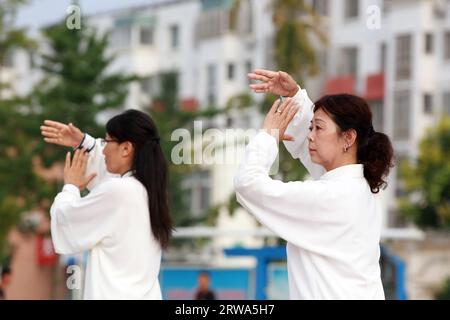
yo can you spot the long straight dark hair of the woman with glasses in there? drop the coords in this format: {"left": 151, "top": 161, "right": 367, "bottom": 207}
{"left": 106, "top": 110, "right": 173, "bottom": 248}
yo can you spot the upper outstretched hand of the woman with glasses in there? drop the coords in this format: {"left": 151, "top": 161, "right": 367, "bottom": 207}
{"left": 41, "top": 120, "right": 84, "bottom": 148}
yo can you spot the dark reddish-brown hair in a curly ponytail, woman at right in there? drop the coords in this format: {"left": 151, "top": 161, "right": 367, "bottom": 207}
{"left": 314, "top": 94, "right": 394, "bottom": 193}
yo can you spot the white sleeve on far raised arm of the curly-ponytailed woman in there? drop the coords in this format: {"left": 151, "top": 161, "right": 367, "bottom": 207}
{"left": 284, "top": 89, "right": 326, "bottom": 180}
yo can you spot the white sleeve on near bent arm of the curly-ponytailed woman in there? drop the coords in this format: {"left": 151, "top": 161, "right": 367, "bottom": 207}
{"left": 234, "top": 132, "right": 346, "bottom": 252}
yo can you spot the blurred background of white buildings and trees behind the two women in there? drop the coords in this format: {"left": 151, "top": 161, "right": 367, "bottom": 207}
{"left": 0, "top": 0, "right": 450, "bottom": 299}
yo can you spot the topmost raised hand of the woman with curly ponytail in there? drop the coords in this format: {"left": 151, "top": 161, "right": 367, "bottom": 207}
{"left": 248, "top": 69, "right": 298, "bottom": 97}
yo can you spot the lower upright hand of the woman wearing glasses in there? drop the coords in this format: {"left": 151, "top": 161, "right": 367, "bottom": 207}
{"left": 64, "top": 149, "right": 96, "bottom": 191}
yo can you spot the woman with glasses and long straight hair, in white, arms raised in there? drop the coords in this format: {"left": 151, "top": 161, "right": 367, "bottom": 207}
{"left": 41, "top": 110, "right": 172, "bottom": 299}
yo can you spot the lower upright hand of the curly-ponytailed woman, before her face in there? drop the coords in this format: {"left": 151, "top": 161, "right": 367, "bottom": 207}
{"left": 262, "top": 98, "right": 299, "bottom": 141}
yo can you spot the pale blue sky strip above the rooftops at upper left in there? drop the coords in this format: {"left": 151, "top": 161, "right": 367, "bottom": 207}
{"left": 16, "top": 0, "right": 165, "bottom": 30}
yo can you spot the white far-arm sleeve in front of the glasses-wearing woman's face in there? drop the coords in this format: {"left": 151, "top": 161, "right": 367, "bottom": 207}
{"left": 81, "top": 133, "right": 117, "bottom": 190}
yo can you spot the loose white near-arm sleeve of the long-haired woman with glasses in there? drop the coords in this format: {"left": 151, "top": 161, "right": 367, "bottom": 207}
{"left": 50, "top": 182, "right": 120, "bottom": 254}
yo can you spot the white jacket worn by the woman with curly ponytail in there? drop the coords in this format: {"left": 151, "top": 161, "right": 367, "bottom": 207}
{"left": 234, "top": 90, "right": 384, "bottom": 299}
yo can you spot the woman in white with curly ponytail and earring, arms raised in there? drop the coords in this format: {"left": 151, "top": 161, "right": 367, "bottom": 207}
{"left": 234, "top": 70, "right": 393, "bottom": 299}
